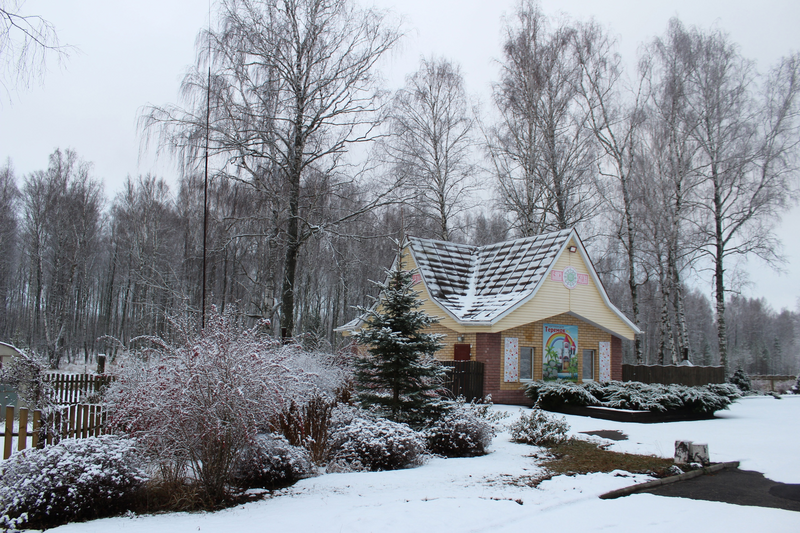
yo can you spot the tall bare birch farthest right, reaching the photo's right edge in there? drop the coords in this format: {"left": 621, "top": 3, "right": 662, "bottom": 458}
{"left": 688, "top": 29, "right": 800, "bottom": 372}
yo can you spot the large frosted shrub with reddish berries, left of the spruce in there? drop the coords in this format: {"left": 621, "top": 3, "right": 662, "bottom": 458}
{"left": 108, "top": 311, "right": 342, "bottom": 502}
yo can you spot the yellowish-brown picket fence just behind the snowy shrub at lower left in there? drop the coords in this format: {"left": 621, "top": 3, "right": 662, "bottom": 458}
{"left": 0, "top": 404, "right": 107, "bottom": 459}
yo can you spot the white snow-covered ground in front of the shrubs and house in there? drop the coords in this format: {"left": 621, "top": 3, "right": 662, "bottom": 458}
{"left": 49, "top": 396, "right": 800, "bottom": 533}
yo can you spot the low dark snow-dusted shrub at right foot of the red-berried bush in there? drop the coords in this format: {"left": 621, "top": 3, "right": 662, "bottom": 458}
{"left": 233, "top": 433, "right": 316, "bottom": 489}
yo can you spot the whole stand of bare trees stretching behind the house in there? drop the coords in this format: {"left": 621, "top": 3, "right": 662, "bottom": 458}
{"left": 0, "top": 0, "right": 800, "bottom": 371}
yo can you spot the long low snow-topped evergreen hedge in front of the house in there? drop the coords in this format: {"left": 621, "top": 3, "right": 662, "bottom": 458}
{"left": 525, "top": 381, "right": 741, "bottom": 415}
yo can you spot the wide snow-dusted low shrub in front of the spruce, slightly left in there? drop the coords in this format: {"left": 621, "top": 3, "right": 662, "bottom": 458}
{"left": 328, "top": 408, "right": 425, "bottom": 471}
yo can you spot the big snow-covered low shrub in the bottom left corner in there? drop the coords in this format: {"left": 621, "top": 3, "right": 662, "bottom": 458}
{"left": 0, "top": 435, "right": 146, "bottom": 529}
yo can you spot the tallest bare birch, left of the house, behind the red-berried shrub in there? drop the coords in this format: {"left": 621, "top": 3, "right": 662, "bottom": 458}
{"left": 143, "top": 0, "right": 399, "bottom": 335}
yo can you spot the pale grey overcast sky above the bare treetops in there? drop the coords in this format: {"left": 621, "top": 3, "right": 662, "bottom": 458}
{"left": 0, "top": 0, "right": 800, "bottom": 310}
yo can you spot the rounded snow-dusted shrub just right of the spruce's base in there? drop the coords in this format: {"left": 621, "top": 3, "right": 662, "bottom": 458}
{"left": 425, "top": 398, "right": 494, "bottom": 457}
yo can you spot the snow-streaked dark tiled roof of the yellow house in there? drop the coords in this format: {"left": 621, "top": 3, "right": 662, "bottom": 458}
{"left": 408, "top": 229, "right": 577, "bottom": 324}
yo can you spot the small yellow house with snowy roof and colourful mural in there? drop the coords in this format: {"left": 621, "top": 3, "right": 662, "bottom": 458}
{"left": 338, "top": 229, "right": 640, "bottom": 404}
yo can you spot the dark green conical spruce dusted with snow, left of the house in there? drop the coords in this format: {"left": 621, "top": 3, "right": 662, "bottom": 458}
{"left": 354, "top": 254, "right": 444, "bottom": 427}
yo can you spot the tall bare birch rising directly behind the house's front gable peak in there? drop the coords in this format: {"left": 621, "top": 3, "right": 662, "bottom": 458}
{"left": 489, "top": 1, "right": 597, "bottom": 235}
